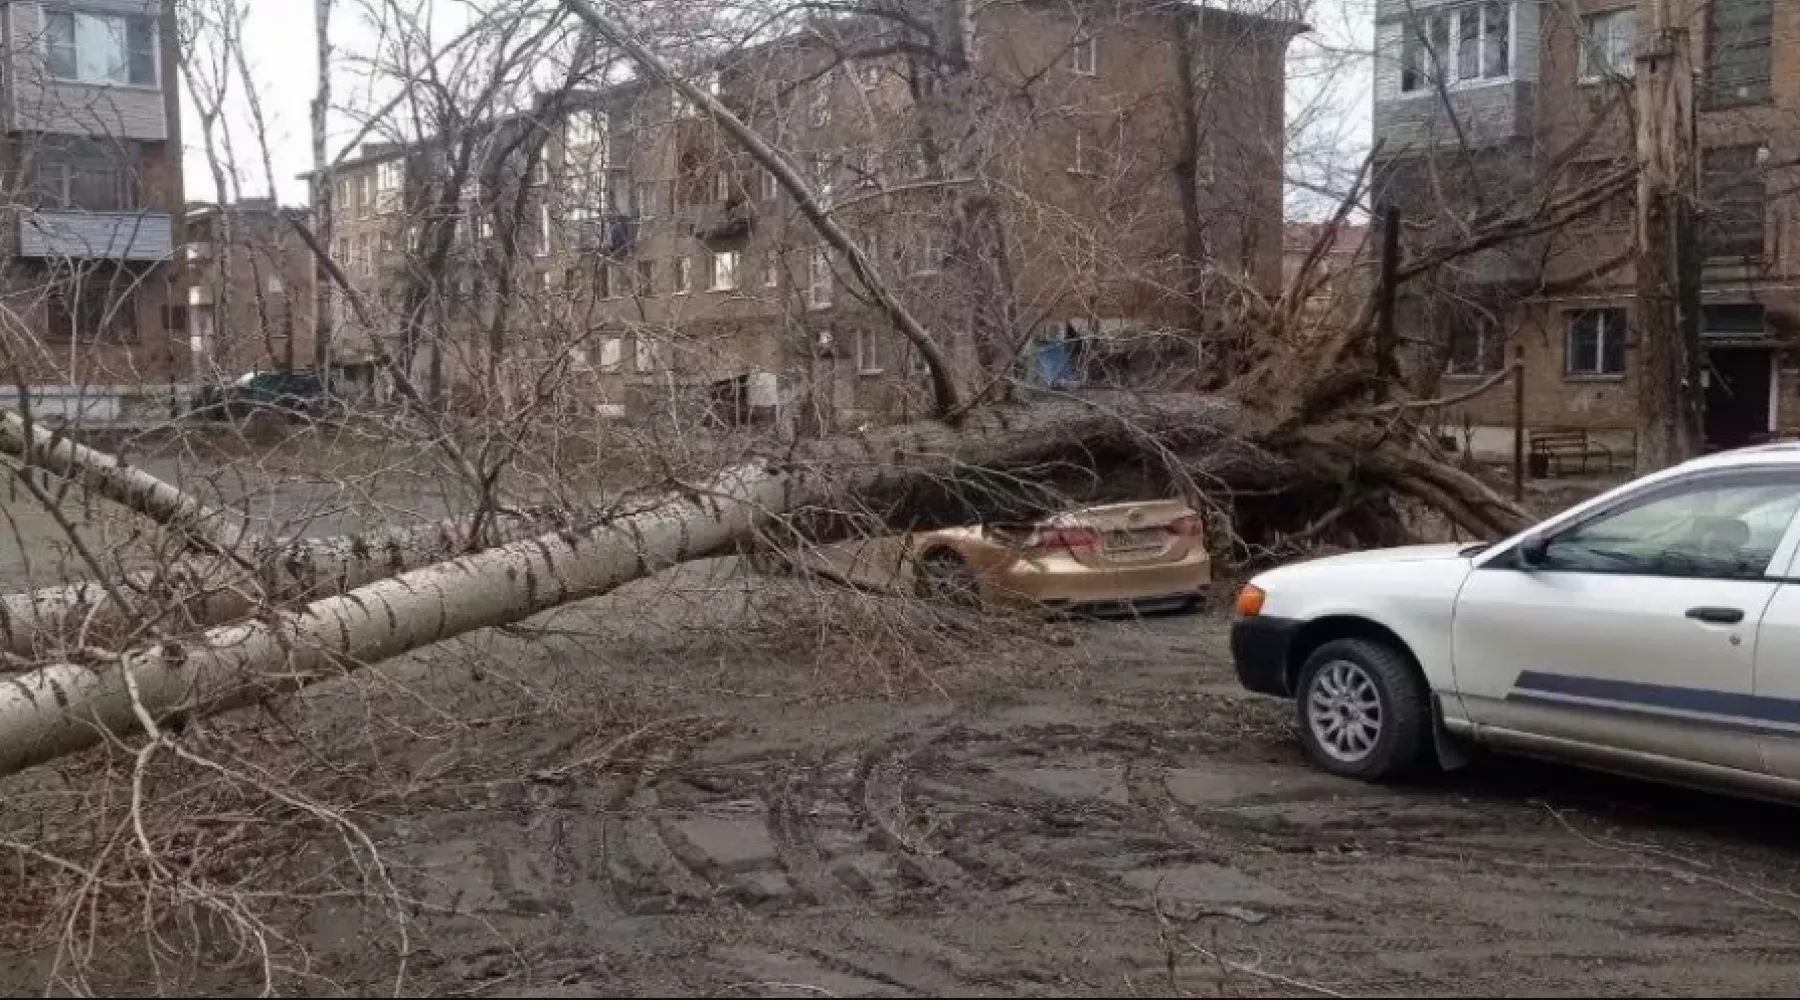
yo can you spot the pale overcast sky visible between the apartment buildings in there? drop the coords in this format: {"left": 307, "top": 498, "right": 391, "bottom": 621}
{"left": 184, "top": 0, "right": 1373, "bottom": 214}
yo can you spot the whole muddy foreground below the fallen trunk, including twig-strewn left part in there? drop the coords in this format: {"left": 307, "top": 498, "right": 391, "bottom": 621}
{"left": 0, "top": 444, "right": 1800, "bottom": 996}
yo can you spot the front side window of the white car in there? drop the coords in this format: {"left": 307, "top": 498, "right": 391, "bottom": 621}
{"left": 1543, "top": 473, "right": 1800, "bottom": 579}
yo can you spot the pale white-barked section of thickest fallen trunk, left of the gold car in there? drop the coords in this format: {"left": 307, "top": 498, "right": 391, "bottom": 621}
{"left": 0, "top": 464, "right": 792, "bottom": 775}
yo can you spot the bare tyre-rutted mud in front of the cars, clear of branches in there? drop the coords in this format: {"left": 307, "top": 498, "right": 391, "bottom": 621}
{"left": 165, "top": 571, "right": 1800, "bottom": 996}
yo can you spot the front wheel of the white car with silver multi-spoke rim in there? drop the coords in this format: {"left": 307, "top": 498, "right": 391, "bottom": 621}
{"left": 1294, "top": 638, "right": 1431, "bottom": 781}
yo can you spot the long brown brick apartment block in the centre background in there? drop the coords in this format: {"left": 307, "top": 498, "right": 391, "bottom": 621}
{"left": 333, "top": 0, "right": 1300, "bottom": 423}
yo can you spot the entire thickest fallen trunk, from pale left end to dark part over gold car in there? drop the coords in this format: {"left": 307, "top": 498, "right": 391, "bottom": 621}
{"left": 0, "top": 399, "right": 1274, "bottom": 773}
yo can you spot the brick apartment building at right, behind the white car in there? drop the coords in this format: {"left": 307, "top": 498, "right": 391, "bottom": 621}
{"left": 1375, "top": 0, "right": 1800, "bottom": 446}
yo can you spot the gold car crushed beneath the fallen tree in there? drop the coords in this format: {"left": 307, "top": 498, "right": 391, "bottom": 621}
{"left": 911, "top": 500, "right": 1213, "bottom": 612}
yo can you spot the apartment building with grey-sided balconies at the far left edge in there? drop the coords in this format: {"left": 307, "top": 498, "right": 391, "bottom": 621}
{"left": 0, "top": 0, "right": 189, "bottom": 419}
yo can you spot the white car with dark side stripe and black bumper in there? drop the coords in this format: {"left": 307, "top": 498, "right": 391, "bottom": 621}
{"left": 1231, "top": 442, "right": 1800, "bottom": 799}
